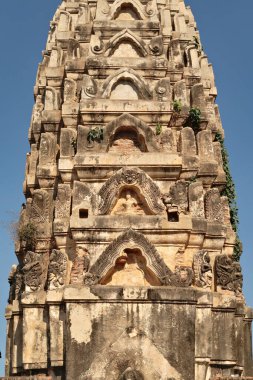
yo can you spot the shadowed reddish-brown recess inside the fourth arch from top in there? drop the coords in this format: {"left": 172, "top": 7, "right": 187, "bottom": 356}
{"left": 108, "top": 125, "right": 147, "bottom": 154}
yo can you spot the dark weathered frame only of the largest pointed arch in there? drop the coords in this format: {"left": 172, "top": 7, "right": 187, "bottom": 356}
{"left": 88, "top": 228, "right": 173, "bottom": 284}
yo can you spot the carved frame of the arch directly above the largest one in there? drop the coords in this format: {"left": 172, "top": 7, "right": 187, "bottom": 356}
{"left": 98, "top": 167, "right": 165, "bottom": 215}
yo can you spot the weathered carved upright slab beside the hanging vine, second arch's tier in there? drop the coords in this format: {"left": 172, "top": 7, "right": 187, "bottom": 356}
{"left": 205, "top": 188, "right": 224, "bottom": 223}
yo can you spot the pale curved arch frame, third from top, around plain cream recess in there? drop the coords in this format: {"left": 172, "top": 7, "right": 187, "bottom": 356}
{"left": 102, "top": 68, "right": 152, "bottom": 99}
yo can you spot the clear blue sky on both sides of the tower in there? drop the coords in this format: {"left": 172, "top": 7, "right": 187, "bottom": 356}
{"left": 0, "top": 0, "right": 253, "bottom": 375}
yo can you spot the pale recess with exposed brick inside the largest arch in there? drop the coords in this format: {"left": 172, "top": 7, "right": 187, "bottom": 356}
{"left": 101, "top": 248, "right": 160, "bottom": 286}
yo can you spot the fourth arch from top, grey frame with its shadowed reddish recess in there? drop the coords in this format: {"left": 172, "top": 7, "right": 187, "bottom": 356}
{"left": 105, "top": 113, "right": 159, "bottom": 153}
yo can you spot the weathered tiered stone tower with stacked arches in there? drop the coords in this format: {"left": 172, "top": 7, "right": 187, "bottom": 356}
{"left": 3, "top": 0, "right": 253, "bottom": 380}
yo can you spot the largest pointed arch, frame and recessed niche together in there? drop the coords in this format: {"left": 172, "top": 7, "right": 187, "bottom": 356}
{"left": 84, "top": 228, "right": 173, "bottom": 286}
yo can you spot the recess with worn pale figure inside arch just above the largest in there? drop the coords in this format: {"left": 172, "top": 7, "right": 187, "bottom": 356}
{"left": 112, "top": 189, "right": 145, "bottom": 215}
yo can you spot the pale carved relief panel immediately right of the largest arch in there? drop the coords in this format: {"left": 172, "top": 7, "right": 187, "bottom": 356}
{"left": 193, "top": 250, "right": 213, "bottom": 289}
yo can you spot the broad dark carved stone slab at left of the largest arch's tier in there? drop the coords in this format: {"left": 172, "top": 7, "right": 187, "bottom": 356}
{"left": 22, "top": 251, "right": 48, "bottom": 292}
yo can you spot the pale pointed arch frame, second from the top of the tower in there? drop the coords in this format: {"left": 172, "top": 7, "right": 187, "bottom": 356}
{"left": 105, "top": 29, "right": 148, "bottom": 57}
